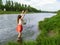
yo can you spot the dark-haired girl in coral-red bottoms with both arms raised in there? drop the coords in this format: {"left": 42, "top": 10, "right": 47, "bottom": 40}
{"left": 16, "top": 11, "right": 26, "bottom": 40}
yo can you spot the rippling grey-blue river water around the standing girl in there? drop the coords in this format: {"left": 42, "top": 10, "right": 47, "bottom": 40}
{"left": 0, "top": 13, "right": 55, "bottom": 45}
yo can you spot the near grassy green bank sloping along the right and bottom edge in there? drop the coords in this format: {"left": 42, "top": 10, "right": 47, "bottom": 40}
{"left": 7, "top": 11, "right": 60, "bottom": 45}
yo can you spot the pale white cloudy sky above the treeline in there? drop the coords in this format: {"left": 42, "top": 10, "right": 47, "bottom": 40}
{"left": 3, "top": 0, "right": 60, "bottom": 11}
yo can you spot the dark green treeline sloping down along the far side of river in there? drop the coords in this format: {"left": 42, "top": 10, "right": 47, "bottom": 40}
{"left": 0, "top": 0, "right": 41, "bottom": 12}
